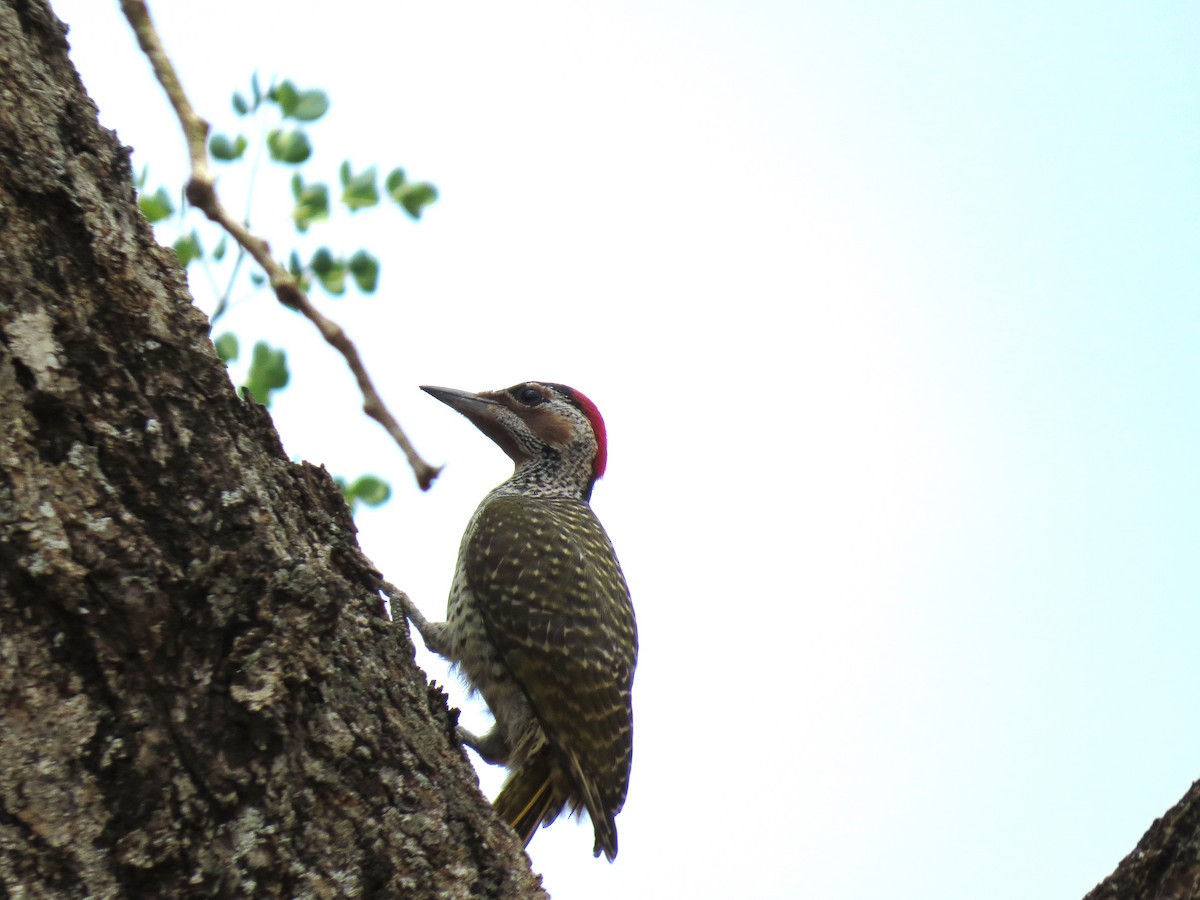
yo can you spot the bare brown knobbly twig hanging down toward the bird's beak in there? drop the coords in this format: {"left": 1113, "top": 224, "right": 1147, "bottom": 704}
{"left": 121, "top": 0, "right": 442, "bottom": 491}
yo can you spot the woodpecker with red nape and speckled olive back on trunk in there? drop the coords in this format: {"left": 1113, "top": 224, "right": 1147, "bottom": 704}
{"left": 398, "top": 382, "right": 637, "bottom": 862}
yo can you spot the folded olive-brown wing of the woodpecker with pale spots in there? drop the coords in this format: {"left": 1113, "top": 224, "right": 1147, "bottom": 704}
{"left": 467, "top": 496, "right": 637, "bottom": 827}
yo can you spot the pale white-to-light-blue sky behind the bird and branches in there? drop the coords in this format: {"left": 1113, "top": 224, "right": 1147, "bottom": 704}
{"left": 55, "top": 0, "right": 1200, "bottom": 900}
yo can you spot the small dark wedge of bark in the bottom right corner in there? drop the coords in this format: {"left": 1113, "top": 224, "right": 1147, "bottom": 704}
{"left": 1084, "top": 781, "right": 1200, "bottom": 900}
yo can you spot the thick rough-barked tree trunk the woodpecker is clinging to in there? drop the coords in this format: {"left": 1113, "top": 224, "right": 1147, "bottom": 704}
{"left": 0, "top": 0, "right": 544, "bottom": 898}
